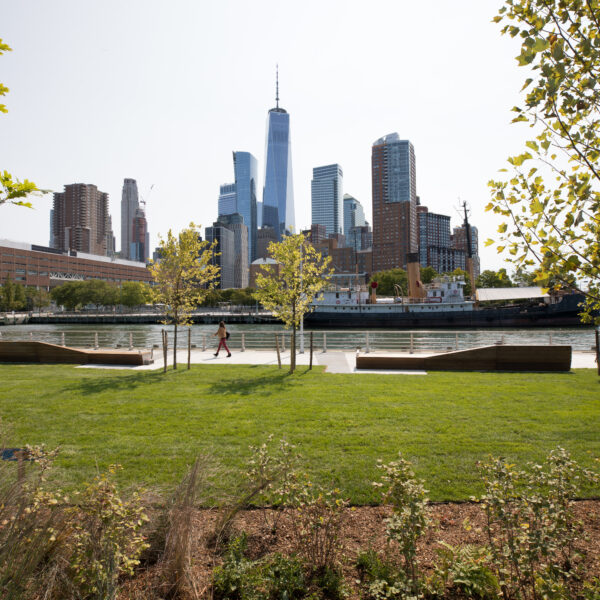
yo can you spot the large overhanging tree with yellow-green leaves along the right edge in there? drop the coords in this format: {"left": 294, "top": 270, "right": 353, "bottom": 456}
{"left": 486, "top": 0, "right": 600, "bottom": 322}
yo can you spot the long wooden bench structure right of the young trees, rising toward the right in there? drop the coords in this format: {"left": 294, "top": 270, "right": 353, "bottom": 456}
{"left": 356, "top": 345, "right": 572, "bottom": 371}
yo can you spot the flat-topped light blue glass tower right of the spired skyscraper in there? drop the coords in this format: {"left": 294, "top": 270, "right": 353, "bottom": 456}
{"left": 310, "top": 164, "right": 344, "bottom": 236}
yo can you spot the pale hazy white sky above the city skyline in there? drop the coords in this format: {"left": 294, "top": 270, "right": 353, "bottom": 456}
{"left": 0, "top": 0, "right": 528, "bottom": 269}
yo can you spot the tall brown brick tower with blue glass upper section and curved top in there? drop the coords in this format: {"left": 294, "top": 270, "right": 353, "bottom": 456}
{"left": 371, "top": 133, "right": 418, "bottom": 271}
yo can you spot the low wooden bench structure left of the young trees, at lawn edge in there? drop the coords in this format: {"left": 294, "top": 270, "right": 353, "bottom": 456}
{"left": 0, "top": 341, "right": 153, "bottom": 365}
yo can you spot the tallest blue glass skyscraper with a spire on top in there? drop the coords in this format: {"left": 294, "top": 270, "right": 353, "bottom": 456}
{"left": 262, "top": 69, "right": 295, "bottom": 240}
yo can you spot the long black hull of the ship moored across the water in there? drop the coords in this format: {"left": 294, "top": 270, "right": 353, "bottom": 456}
{"left": 304, "top": 294, "right": 583, "bottom": 329}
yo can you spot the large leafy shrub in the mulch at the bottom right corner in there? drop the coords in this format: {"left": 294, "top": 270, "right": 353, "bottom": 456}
{"left": 480, "top": 448, "right": 598, "bottom": 600}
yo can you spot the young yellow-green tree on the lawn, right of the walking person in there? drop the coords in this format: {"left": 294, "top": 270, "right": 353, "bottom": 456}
{"left": 256, "top": 234, "right": 332, "bottom": 373}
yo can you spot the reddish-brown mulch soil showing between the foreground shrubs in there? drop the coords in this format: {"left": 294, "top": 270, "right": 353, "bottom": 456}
{"left": 121, "top": 500, "right": 600, "bottom": 598}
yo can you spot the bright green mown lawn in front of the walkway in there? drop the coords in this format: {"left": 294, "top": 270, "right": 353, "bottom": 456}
{"left": 0, "top": 365, "right": 600, "bottom": 503}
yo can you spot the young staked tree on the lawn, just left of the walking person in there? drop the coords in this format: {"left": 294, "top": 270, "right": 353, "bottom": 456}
{"left": 150, "top": 223, "right": 219, "bottom": 369}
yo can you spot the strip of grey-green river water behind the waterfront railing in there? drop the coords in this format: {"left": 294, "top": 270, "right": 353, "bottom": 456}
{"left": 0, "top": 324, "right": 595, "bottom": 351}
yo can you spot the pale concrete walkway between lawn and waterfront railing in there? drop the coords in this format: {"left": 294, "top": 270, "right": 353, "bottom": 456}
{"left": 78, "top": 349, "right": 596, "bottom": 375}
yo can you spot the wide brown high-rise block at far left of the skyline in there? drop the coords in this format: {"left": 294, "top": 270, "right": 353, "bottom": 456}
{"left": 52, "top": 183, "right": 112, "bottom": 256}
